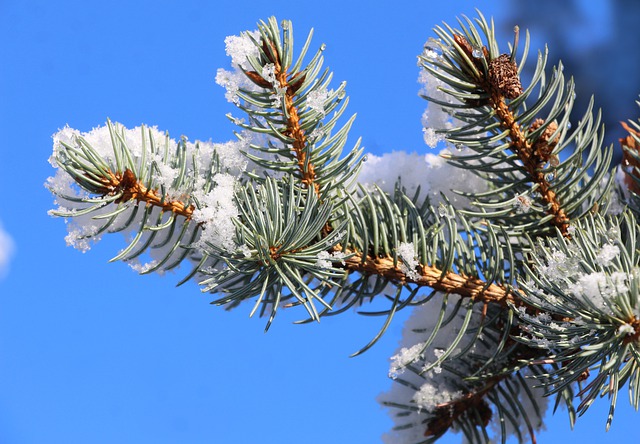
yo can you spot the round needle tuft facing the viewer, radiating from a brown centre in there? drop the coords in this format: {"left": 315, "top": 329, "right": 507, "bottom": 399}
{"left": 200, "top": 176, "right": 349, "bottom": 329}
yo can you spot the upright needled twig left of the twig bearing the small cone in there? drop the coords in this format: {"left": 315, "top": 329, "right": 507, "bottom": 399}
{"left": 220, "top": 17, "right": 362, "bottom": 199}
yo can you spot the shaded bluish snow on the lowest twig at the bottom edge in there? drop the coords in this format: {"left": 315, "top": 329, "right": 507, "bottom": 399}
{"left": 378, "top": 293, "right": 548, "bottom": 444}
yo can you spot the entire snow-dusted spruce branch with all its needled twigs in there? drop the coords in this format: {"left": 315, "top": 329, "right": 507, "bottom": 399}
{"left": 48, "top": 14, "right": 640, "bottom": 442}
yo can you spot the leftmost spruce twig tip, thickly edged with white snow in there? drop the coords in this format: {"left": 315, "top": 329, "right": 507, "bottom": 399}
{"left": 47, "top": 121, "right": 242, "bottom": 273}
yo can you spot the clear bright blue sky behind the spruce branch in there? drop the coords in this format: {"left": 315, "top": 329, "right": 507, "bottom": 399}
{"left": 0, "top": 0, "right": 637, "bottom": 444}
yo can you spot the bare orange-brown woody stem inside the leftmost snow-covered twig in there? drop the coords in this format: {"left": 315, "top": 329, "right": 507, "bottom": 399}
{"left": 96, "top": 168, "right": 195, "bottom": 219}
